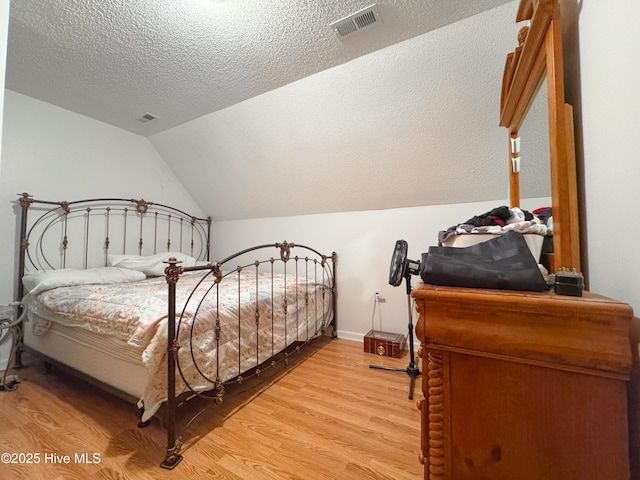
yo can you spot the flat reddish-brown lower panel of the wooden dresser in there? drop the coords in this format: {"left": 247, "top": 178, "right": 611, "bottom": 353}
{"left": 450, "top": 354, "right": 629, "bottom": 480}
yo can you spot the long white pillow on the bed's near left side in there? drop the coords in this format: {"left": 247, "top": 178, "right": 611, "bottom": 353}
{"left": 22, "top": 267, "right": 146, "bottom": 295}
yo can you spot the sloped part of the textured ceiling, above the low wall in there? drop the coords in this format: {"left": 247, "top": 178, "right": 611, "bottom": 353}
{"left": 148, "top": 2, "right": 536, "bottom": 221}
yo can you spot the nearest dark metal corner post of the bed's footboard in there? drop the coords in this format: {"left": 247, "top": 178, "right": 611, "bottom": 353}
{"left": 160, "top": 257, "right": 184, "bottom": 470}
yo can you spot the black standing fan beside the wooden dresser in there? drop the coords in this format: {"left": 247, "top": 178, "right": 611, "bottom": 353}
{"left": 369, "top": 240, "right": 420, "bottom": 400}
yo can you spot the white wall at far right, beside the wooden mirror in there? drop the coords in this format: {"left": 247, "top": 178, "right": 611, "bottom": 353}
{"left": 579, "top": 0, "right": 640, "bottom": 315}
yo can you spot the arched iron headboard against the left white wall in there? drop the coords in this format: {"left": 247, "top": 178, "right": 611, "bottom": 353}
{"left": 18, "top": 193, "right": 211, "bottom": 299}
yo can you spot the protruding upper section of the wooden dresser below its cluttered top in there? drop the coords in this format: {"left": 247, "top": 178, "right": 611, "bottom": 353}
{"left": 412, "top": 284, "right": 633, "bottom": 380}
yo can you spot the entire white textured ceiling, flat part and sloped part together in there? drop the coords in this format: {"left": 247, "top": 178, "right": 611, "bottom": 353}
{"left": 7, "top": 0, "right": 548, "bottom": 221}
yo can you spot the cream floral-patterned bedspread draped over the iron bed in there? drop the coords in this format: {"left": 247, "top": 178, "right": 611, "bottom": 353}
{"left": 25, "top": 269, "right": 331, "bottom": 421}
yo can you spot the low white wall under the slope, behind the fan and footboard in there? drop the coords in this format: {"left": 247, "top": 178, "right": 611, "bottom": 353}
{"left": 213, "top": 202, "right": 512, "bottom": 341}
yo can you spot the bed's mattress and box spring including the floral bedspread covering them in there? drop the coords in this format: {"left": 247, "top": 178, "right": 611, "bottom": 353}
{"left": 25, "top": 270, "right": 331, "bottom": 421}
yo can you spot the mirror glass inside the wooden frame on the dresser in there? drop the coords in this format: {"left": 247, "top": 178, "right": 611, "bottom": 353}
{"left": 518, "top": 78, "right": 551, "bottom": 205}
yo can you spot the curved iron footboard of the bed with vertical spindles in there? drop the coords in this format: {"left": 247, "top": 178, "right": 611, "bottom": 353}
{"left": 161, "top": 241, "right": 337, "bottom": 469}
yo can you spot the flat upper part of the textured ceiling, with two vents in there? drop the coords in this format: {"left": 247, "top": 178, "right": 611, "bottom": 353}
{"left": 6, "top": 0, "right": 510, "bottom": 136}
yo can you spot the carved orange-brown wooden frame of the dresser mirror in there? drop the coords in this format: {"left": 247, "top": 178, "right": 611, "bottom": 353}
{"left": 500, "top": 0, "right": 581, "bottom": 272}
